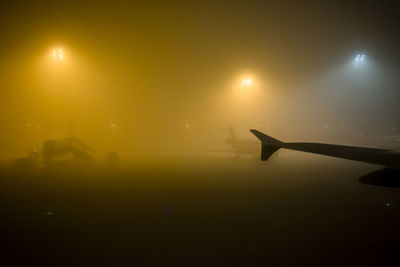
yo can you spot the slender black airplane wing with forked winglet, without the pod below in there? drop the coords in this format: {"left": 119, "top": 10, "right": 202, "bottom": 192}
{"left": 250, "top": 129, "right": 400, "bottom": 169}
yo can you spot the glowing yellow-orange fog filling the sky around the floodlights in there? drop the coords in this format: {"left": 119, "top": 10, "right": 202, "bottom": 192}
{"left": 0, "top": 2, "right": 399, "bottom": 162}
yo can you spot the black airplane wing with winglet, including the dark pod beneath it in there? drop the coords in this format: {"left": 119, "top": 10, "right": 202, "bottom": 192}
{"left": 250, "top": 129, "right": 400, "bottom": 187}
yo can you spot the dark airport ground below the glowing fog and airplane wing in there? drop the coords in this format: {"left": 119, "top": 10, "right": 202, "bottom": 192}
{"left": 0, "top": 153, "right": 400, "bottom": 266}
